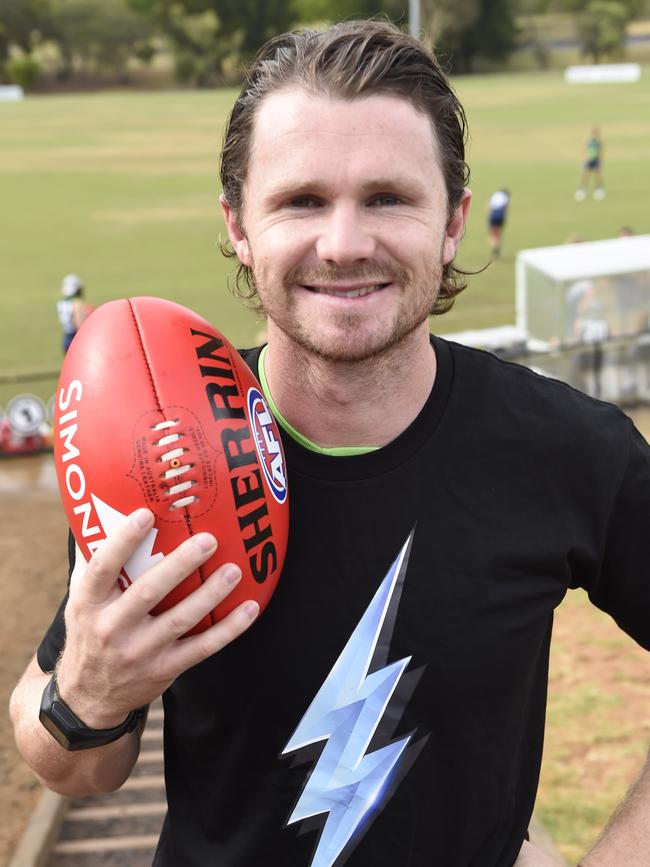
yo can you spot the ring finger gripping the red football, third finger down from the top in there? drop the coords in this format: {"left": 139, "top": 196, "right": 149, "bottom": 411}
{"left": 152, "top": 563, "right": 241, "bottom": 646}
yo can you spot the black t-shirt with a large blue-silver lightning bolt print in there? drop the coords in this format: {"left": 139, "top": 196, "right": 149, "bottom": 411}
{"left": 38, "top": 338, "right": 650, "bottom": 867}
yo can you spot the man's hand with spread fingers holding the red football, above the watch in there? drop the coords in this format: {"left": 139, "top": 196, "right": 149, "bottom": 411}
{"left": 57, "top": 509, "right": 259, "bottom": 728}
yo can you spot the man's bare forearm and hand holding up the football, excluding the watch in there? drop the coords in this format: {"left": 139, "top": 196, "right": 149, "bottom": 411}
{"left": 10, "top": 509, "right": 259, "bottom": 797}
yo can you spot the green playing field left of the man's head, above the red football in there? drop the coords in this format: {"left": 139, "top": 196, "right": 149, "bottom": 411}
{"left": 0, "top": 91, "right": 259, "bottom": 402}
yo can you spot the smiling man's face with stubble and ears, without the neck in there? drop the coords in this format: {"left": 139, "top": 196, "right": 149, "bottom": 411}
{"left": 223, "top": 88, "right": 469, "bottom": 361}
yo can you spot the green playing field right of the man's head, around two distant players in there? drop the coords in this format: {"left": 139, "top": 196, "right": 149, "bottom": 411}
{"left": 441, "top": 70, "right": 650, "bottom": 330}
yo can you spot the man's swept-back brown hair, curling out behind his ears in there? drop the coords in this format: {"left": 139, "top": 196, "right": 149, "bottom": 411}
{"left": 221, "top": 20, "right": 469, "bottom": 314}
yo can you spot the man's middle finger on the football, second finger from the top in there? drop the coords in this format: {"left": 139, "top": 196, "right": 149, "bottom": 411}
{"left": 117, "top": 533, "right": 217, "bottom": 626}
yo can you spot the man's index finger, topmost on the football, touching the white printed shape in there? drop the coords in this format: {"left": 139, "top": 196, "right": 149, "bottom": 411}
{"left": 79, "top": 509, "right": 154, "bottom": 603}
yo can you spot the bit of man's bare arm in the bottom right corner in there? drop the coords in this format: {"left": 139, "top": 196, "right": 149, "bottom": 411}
{"left": 580, "top": 755, "right": 650, "bottom": 867}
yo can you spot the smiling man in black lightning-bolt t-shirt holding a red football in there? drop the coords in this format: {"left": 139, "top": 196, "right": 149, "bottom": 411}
{"left": 12, "top": 22, "right": 650, "bottom": 867}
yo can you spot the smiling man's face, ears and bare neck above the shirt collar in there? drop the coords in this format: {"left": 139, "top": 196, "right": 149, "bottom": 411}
{"left": 222, "top": 85, "right": 470, "bottom": 446}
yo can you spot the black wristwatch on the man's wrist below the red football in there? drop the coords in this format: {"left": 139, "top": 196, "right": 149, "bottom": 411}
{"left": 38, "top": 672, "right": 146, "bottom": 750}
